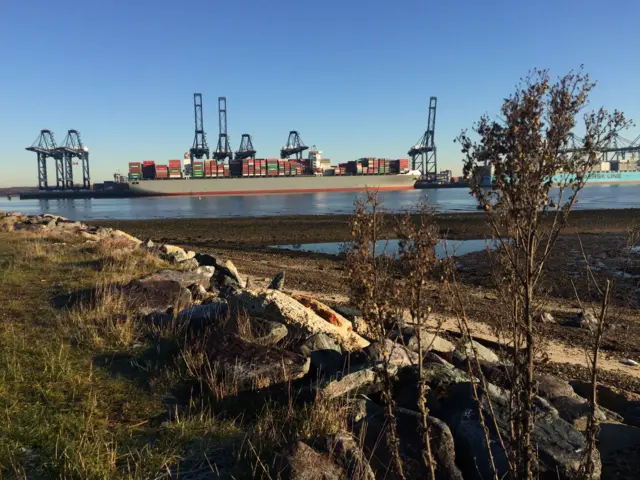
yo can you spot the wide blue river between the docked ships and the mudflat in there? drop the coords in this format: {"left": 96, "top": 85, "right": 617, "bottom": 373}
{"left": 0, "top": 185, "right": 640, "bottom": 220}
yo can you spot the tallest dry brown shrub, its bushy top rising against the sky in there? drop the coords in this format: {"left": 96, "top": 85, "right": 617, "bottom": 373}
{"left": 458, "top": 66, "right": 629, "bottom": 479}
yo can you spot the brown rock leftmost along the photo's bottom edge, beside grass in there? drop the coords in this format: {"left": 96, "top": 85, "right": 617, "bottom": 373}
{"left": 274, "top": 442, "right": 348, "bottom": 480}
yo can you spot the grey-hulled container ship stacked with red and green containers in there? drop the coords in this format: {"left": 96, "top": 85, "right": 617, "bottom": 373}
{"left": 111, "top": 150, "right": 420, "bottom": 196}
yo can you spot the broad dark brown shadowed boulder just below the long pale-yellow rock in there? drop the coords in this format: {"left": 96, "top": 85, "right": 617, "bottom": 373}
{"left": 207, "top": 332, "right": 310, "bottom": 390}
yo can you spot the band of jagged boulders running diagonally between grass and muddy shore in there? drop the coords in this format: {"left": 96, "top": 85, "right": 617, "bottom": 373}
{"left": 0, "top": 213, "right": 640, "bottom": 479}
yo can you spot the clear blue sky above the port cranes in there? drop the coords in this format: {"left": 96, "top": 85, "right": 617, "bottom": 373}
{"left": 0, "top": 0, "right": 640, "bottom": 186}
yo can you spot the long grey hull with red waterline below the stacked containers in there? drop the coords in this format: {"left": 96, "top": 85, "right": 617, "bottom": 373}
{"left": 129, "top": 175, "right": 417, "bottom": 196}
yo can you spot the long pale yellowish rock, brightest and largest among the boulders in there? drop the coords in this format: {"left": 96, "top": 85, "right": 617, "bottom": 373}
{"left": 227, "top": 290, "right": 369, "bottom": 351}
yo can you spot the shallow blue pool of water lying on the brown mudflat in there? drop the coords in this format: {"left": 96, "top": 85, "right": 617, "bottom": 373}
{"left": 270, "top": 240, "right": 496, "bottom": 258}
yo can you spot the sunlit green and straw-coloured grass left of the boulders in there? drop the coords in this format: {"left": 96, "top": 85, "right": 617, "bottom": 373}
{"left": 0, "top": 232, "right": 346, "bottom": 479}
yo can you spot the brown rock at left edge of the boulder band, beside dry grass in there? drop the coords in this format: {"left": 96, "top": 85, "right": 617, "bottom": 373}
{"left": 123, "top": 277, "right": 192, "bottom": 315}
